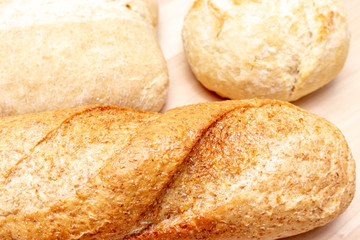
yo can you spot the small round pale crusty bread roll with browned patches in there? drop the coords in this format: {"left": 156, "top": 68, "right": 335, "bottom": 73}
{"left": 182, "top": 0, "right": 350, "bottom": 101}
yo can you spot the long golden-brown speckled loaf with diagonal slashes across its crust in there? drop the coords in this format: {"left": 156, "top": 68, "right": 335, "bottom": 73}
{"left": 0, "top": 100, "right": 355, "bottom": 240}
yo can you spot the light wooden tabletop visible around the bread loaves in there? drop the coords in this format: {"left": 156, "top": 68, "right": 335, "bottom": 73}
{"left": 158, "top": 0, "right": 360, "bottom": 240}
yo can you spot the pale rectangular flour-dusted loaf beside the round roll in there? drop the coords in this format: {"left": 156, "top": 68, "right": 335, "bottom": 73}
{"left": 0, "top": 0, "right": 168, "bottom": 116}
